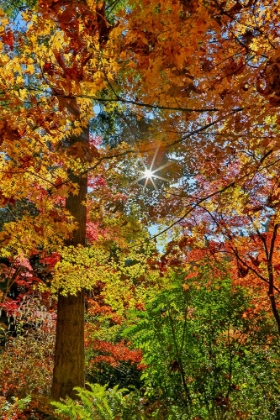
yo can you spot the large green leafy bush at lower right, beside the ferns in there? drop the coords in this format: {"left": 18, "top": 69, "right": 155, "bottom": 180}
{"left": 124, "top": 268, "right": 280, "bottom": 419}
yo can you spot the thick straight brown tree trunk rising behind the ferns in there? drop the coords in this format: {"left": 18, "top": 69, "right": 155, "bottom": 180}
{"left": 52, "top": 125, "right": 89, "bottom": 400}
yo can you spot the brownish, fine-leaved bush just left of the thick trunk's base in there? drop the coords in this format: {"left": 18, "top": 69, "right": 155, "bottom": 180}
{"left": 0, "top": 295, "right": 55, "bottom": 401}
